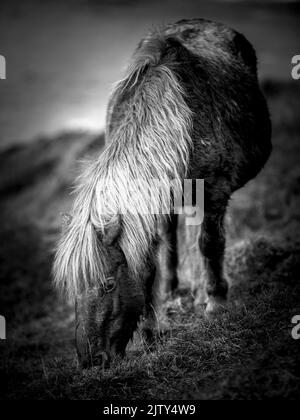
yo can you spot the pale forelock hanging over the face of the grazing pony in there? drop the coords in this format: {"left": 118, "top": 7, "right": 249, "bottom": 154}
{"left": 53, "top": 203, "right": 104, "bottom": 300}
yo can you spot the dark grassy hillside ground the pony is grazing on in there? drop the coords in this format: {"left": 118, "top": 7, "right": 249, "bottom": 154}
{"left": 0, "top": 83, "right": 300, "bottom": 399}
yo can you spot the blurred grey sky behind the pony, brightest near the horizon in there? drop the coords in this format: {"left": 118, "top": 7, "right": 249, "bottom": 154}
{"left": 0, "top": 0, "right": 300, "bottom": 147}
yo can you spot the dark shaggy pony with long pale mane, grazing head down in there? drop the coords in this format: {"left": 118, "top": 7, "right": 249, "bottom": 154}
{"left": 54, "top": 19, "right": 271, "bottom": 367}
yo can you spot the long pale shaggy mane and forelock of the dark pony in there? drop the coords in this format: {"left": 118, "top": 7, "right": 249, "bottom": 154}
{"left": 54, "top": 35, "right": 192, "bottom": 298}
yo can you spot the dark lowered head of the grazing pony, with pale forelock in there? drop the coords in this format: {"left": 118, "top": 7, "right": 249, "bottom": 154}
{"left": 55, "top": 213, "right": 151, "bottom": 367}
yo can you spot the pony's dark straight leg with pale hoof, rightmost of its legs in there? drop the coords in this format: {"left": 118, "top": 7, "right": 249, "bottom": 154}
{"left": 199, "top": 197, "right": 228, "bottom": 314}
